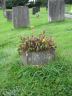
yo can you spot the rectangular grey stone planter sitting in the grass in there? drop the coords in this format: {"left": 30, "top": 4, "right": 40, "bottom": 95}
{"left": 20, "top": 48, "right": 55, "bottom": 65}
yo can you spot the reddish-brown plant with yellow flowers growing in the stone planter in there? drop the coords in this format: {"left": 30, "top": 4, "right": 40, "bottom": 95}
{"left": 18, "top": 28, "right": 56, "bottom": 53}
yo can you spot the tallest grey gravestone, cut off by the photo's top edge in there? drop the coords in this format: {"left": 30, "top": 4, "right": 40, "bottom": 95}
{"left": 48, "top": 0, "right": 65, "bottom": 22}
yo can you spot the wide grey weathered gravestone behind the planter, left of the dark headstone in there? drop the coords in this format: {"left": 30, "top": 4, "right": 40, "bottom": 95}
{"left": 12, "top": 6, "right": 30, "bottom": 28}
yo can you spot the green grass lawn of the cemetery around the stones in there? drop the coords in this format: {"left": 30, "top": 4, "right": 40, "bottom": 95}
{"left": 0, "top": 6, "right": 72, "bottom": 96}
